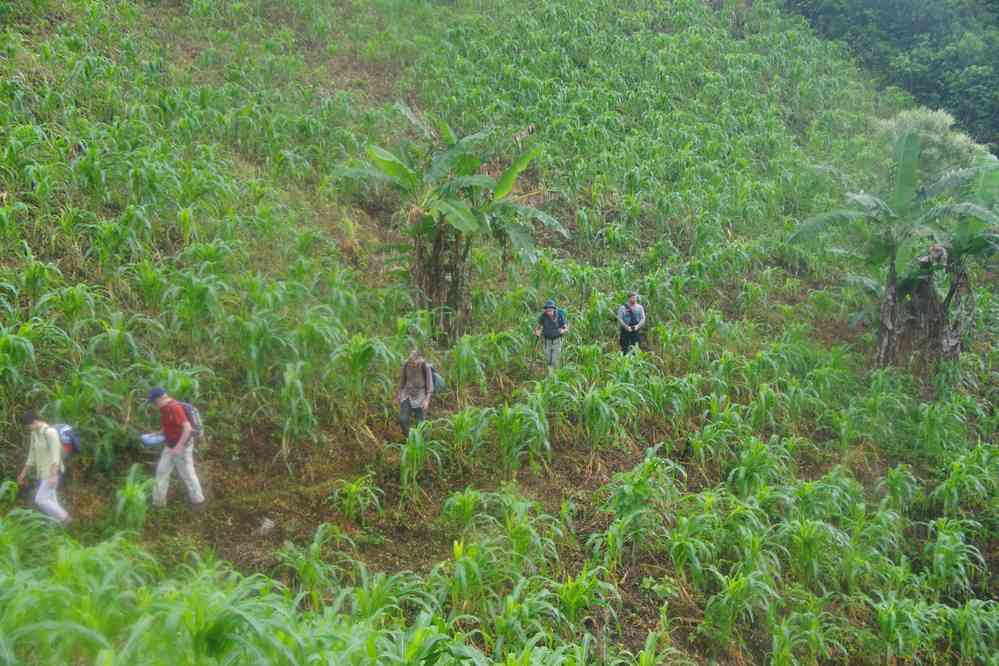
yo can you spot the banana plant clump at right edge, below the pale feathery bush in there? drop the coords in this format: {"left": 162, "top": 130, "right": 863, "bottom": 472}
{"left": 791, "top": 129, "right": 999, "bottom": 366}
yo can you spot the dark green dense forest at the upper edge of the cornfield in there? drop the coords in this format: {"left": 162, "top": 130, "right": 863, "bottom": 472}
{"left": 786, "top": 0, "right": 999, "bottom": 146}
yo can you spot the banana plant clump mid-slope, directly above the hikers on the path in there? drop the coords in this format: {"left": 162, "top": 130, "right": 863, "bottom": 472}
{"left": 341, "top": 108, "right": 566, "bottom": 338}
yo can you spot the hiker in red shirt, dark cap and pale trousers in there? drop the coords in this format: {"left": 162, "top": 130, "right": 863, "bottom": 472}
{"left": 149, "top": 386, "right": 205, "bottom": 506}
